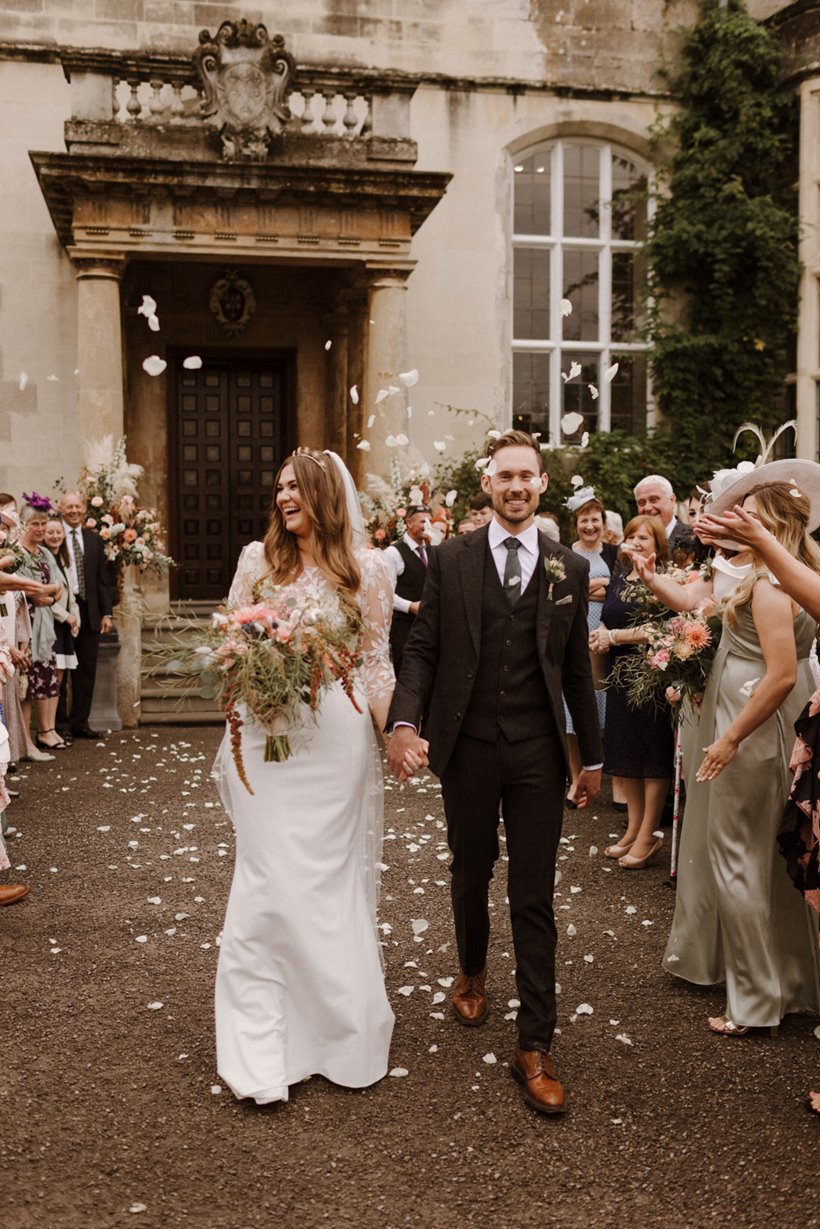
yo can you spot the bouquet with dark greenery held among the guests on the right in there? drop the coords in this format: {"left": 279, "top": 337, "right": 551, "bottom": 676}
{"left": 612, "top": 568, "right": 720, "bottom": 721}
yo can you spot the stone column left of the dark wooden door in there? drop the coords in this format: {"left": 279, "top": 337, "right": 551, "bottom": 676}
{"left": 74, "top": 258, "right": 124, "bottom": 441}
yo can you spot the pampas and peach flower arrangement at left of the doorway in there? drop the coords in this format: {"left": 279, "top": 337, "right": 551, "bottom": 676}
{"left": 80, "top": 435, "right": 173, "bottom": 573}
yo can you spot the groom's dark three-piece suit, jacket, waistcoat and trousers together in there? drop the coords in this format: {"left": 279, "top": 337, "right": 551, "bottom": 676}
{"left": 390, "top": 528, "right": 602, "bottom": 1050}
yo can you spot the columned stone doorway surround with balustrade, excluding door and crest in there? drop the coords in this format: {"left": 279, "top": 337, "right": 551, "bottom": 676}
{"left": 30, "top": 31, "right": 450, "bottom": 725}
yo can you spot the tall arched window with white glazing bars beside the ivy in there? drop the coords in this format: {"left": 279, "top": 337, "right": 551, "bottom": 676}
{"left": 513, "top": 139, "right": 649, "bottom": 444}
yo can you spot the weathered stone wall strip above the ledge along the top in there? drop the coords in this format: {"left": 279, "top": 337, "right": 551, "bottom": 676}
{"left": 0, "top": 0, "right": 708, "bottom": 91}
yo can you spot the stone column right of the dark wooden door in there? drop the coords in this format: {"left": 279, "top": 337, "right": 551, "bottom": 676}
{"left": 361, "top": 269, "right": 409, "bottom": 477}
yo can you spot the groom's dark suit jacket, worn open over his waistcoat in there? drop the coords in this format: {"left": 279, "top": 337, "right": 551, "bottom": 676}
{"left": 388, "top": 526, "right": 604, "bottom": 777}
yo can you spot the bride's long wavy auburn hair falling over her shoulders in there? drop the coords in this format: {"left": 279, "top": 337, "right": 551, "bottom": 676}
{"left": 264, "top": 449, "right": 361, "bottom": 597}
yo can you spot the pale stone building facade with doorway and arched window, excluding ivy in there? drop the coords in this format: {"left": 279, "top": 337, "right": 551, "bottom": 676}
{"left": 0, "top": 0, "right": 820, "bottom": 717}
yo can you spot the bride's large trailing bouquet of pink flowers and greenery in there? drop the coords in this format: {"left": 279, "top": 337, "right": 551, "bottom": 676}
{"left": 158, "top": 599, "right": 361, "bottom": 794}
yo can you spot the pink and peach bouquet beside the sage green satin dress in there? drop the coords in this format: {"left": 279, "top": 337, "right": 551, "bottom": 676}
{"left": 613, "top": 601, "right": 720, "bottom": 718}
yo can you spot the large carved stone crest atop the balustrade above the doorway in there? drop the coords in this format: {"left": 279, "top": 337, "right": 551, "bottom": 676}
{"left": 193, "top": 18, "right": 295, "bottom": 162}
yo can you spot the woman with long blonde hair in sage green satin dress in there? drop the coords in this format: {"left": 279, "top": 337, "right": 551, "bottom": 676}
{"left": 664, "top": 474, "right": 820, "bottom": 1036}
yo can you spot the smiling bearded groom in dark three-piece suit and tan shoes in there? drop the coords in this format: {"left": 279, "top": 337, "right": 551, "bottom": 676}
{"left": 387, "top": 430, "right": 602, "bottom": 1113}
